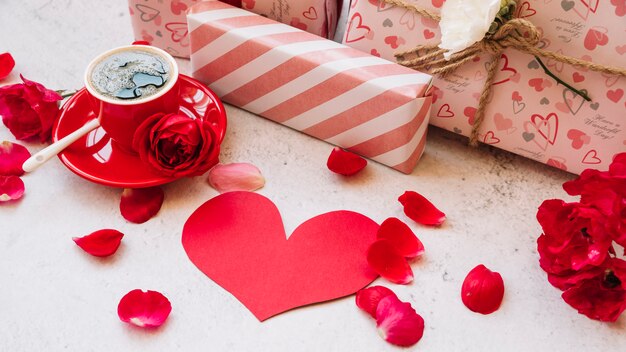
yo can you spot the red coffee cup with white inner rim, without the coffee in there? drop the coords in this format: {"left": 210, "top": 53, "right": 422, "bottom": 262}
{"left": 85, "top": 45, "right": 180, "bottom": 151}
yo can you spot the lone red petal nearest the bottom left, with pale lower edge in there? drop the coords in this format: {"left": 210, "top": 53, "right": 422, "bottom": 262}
{"left": 117, "top": 289, "right": 172, "bottom": 328}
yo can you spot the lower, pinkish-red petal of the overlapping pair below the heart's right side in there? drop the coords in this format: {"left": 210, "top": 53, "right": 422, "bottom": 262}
{"left": 376, "top": 295, "right": 424, "bottom": 346}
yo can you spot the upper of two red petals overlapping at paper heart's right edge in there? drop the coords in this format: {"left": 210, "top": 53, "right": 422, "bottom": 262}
{"left": 377, "top": 218, "right": 424, "bottom": 258}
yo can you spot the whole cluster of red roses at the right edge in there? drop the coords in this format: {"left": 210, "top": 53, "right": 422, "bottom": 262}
{"left": 537, "top": 153, "right": 626, "bottom": 322}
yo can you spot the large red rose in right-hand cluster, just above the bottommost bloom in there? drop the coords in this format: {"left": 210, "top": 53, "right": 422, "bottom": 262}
{"left": 537, "top": 199, "right": 612, "bottom": 276}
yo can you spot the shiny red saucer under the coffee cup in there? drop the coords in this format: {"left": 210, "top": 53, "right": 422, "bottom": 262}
{"left": 52, "top": 75, "right": 226, "bottom": 188}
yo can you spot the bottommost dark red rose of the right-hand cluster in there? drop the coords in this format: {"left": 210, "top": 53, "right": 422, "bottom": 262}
{"left": 562, "top": 258, "right": 626, "bottom": 322}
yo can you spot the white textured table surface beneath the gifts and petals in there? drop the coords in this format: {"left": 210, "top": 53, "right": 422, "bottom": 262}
{"left": 0, "top": 0, "right": 626, "bottom": 351}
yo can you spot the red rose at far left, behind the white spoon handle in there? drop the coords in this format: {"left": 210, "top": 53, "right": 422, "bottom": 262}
{"left": 0, "top": 76, "right": 62, "bottom": 142}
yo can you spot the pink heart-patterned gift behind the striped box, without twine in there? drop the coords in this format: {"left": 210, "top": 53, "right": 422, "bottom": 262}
{"left": 128, "top": 0, "right": 341, "bottom": 58}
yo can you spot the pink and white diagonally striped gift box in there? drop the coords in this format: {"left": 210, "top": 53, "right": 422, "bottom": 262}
{"left": 187, "top": 2, "right": 431, "bottom": 173}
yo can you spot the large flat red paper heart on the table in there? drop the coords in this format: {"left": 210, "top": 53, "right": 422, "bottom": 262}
{"left": 182, "top": 192, "right": 379, "bottom": 321}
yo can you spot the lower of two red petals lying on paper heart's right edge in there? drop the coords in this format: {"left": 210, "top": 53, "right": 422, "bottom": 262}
{"left": 367, "top": 239, "right": 413, "bottom": 285}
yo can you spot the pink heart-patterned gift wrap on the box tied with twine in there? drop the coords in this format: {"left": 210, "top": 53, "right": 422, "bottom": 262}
{"left": 343, "top": 0, "right": 626, "bottom": 173}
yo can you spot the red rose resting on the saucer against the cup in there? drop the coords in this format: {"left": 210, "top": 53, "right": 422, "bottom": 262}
{"left": 133, "top": 113, "right": 220, "bottom": 177}
